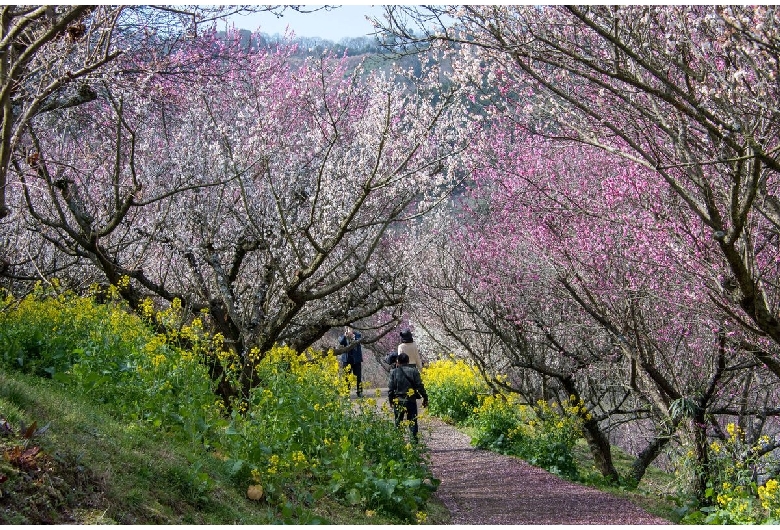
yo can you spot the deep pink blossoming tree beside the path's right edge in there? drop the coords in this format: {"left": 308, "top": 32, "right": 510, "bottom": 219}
{"left": 408, "top": 120, "right": 773, "bottom": 492}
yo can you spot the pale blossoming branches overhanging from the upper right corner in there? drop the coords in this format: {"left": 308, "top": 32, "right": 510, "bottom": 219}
{"left": 385, "top": 6, "right": 780, "bottom": 376}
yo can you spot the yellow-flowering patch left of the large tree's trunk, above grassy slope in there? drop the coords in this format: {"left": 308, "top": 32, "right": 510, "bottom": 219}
{"left": 0, "top": 281, "right": 220, "bottom": 441}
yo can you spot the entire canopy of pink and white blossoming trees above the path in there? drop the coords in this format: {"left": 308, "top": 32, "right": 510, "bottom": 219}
{"left": 0, "top": 5, "right": 780, "bottom": 499}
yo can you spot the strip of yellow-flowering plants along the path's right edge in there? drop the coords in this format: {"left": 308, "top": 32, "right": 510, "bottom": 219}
{"left": 423, "top": 358, "right": 680, "bottom": 521}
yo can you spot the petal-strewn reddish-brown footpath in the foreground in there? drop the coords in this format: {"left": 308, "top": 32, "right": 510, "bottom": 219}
{"left": 368, "top": 389, "right": 672, "bottom": 525}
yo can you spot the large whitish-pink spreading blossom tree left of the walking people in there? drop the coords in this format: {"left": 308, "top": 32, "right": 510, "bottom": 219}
{"left": 6, "top": 29, "right": 466, "bottom": 392}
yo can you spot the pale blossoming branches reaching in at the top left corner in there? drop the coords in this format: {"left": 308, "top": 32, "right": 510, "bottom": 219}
{"left": 0, "top": 5, "right": 284, "bottom": 219}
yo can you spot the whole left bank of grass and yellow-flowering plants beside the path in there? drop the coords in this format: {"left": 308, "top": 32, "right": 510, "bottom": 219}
{"left": 0, "top": 283, "right": 437, "bottom": 524}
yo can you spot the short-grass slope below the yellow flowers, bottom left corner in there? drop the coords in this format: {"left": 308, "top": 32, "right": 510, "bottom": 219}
{"left": 0, "top": 372, "right": 418, "bottom": 524}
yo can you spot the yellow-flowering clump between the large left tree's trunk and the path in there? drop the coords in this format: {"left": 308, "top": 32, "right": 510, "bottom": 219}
{"left": 221, "top": 347, "right": 436, "bottom": 521}
